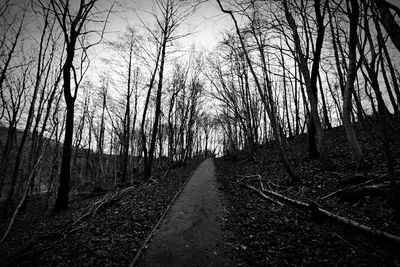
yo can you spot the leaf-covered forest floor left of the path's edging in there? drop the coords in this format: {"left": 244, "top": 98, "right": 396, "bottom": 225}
{"left": 0, "top": 161, "right": 199, "bottom": 266}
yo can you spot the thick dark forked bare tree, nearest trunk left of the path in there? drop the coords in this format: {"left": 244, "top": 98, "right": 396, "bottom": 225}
{"left": 50, "top": 0, "right": 109, "bottom": 213}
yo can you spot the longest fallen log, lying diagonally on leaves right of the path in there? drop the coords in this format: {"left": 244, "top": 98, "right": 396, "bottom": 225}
{"left": 242, "top": 183, "right": 400, "bottom": 246}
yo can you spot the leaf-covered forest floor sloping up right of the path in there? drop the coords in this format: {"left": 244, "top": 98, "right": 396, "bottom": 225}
{"left": 215, "top": 118, "right": 400, "bottom": 266}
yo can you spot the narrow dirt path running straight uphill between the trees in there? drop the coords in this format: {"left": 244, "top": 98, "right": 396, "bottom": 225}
{"left": 139, "top": 159, "right": 235, "bottom": 266}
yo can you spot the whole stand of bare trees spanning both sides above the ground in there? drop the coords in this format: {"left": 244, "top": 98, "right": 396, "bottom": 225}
{"left": 0, "top": 0, "right": 400, "bottom": 226}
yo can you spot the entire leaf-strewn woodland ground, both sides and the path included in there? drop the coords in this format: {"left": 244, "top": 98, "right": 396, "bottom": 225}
{"left": 0, "top": 118, "right": 400, "bottom": 266}
